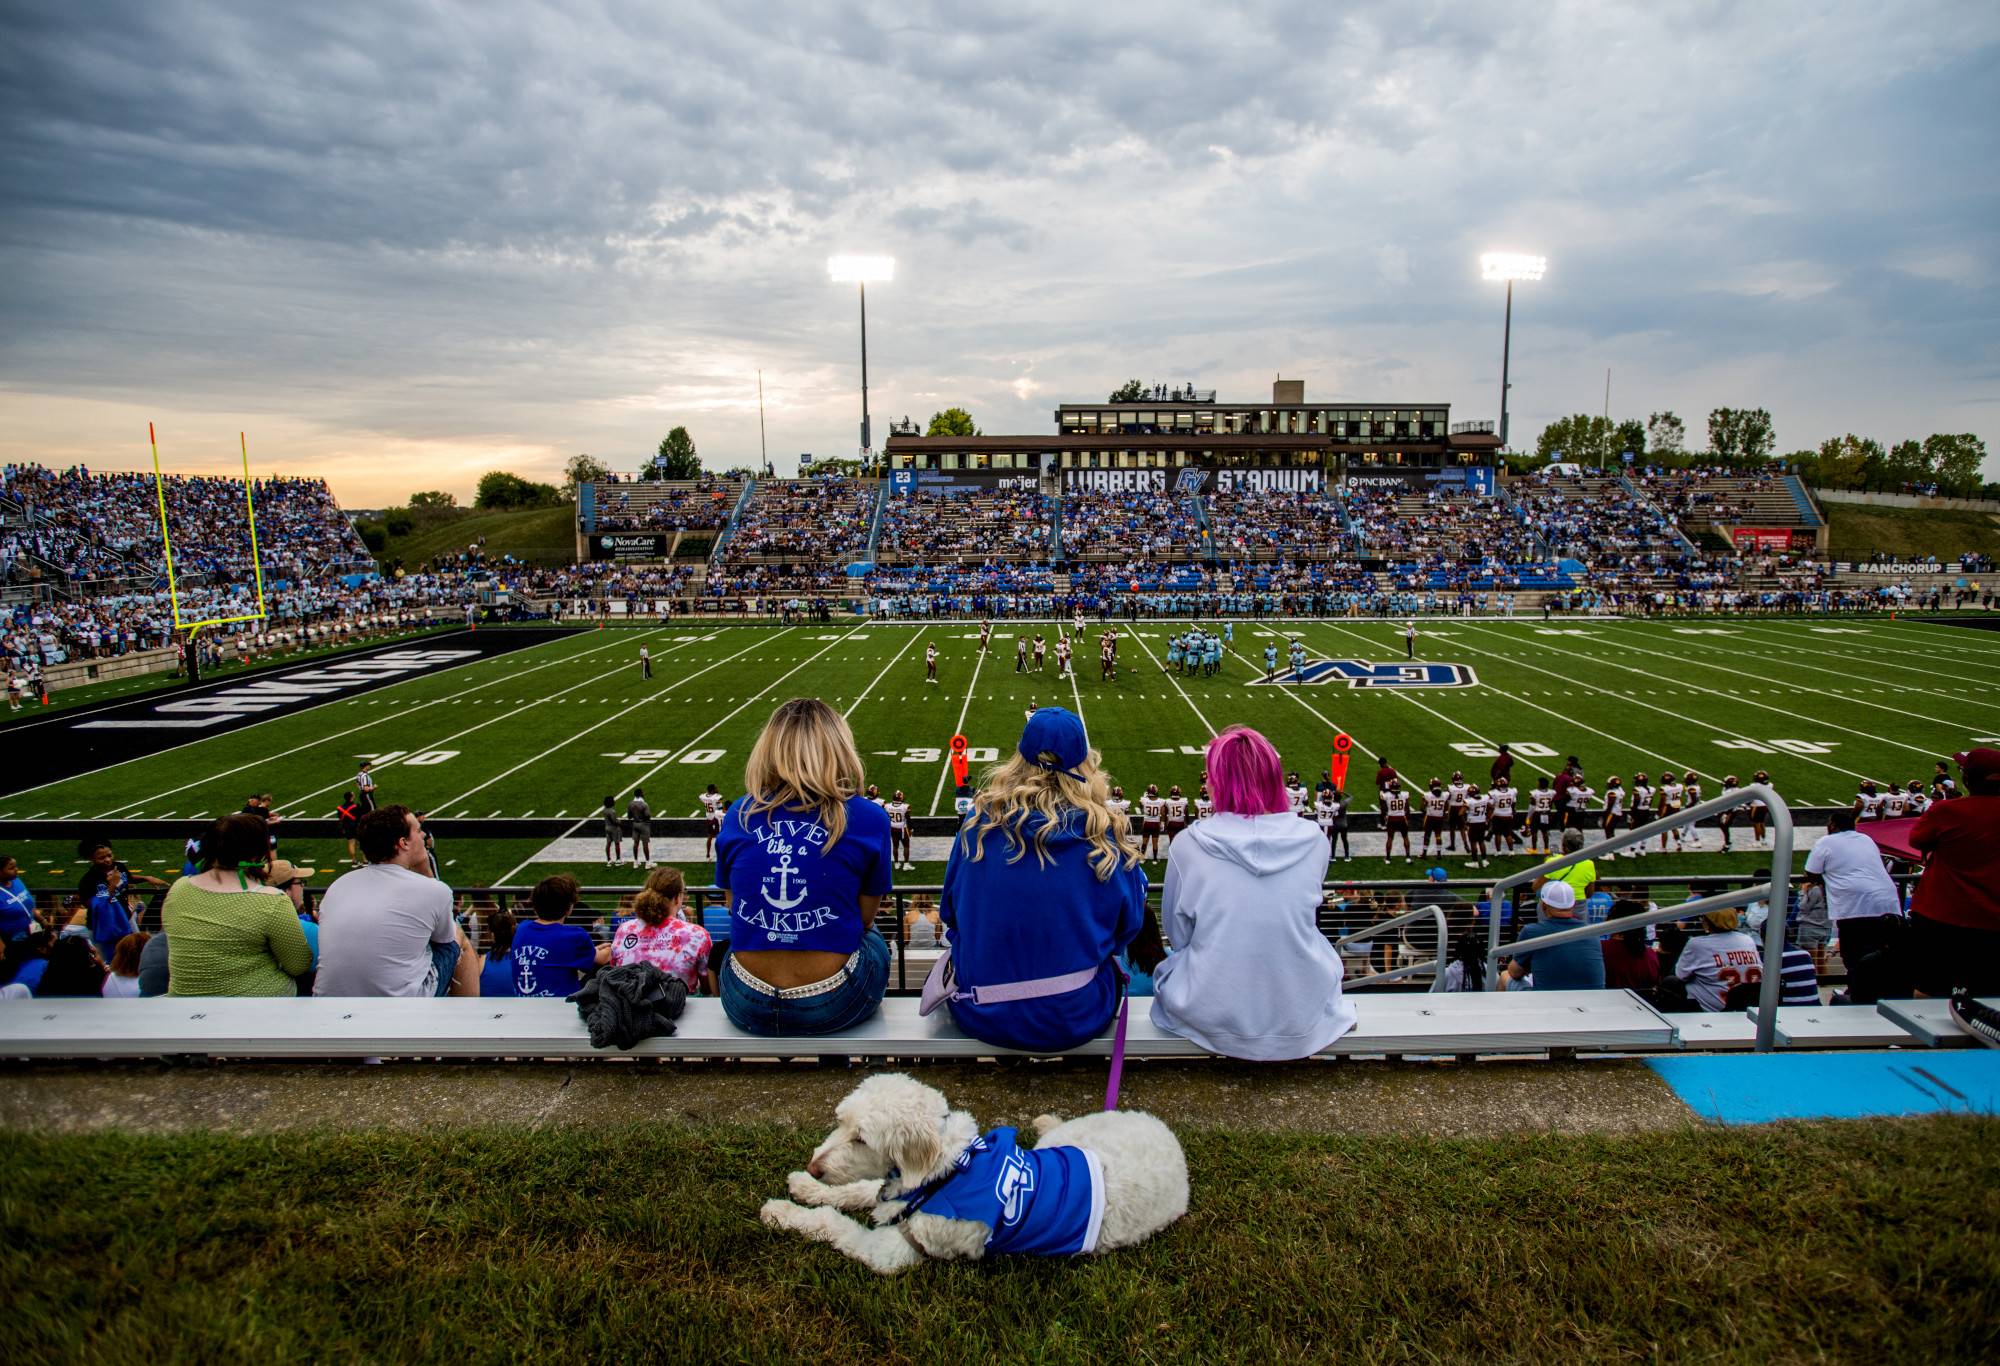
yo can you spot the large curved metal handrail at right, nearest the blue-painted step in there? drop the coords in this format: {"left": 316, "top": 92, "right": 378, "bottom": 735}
{"left": 1486, "top": 782, "right": 1792, "bottom": 1052}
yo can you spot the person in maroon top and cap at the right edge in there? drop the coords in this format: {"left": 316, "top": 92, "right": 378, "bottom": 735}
{"left": 1908, "top": 748, "right": 2000, "bottom": 996}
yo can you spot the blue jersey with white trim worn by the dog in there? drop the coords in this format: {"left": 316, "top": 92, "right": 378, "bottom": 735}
{"left": 918, "top": 1128, "right": 1104, "bottom": 1256}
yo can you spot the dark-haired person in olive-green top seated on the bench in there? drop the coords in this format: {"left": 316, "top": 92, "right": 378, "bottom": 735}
{"left": 160, "top": 812, "right": 312, "bottom": 996}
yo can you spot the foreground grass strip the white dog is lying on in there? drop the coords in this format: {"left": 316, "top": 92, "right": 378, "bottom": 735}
{"left": 0, "top": 1118, "right": 2000, "bottom": 1362}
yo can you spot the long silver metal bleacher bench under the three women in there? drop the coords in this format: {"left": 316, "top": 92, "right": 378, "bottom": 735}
{"left": 0, "top": 992, "right": 1678, "bottom": 1058}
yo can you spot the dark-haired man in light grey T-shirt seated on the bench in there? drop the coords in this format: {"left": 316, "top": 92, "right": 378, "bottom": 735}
{"left": 318, "top": 806, "right": 478, "bottom": 996}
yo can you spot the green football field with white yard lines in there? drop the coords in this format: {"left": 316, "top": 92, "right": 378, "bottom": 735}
{"left": 0, "top": 618, "right": 2000, "bottom": 886}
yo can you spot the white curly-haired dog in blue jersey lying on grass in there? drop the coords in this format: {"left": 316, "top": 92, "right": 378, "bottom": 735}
{"left": 760, "top": 1072, "right": 1188, "bottom": 1274}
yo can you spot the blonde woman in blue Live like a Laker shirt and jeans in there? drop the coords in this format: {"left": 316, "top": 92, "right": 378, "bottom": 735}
{"left": 716, "top": 698, "right": 892, "bottom": 1036}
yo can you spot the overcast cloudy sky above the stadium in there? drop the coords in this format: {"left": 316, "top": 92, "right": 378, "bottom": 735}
{"left": 0, "top": 0, "right": 2000, "bottom": 506}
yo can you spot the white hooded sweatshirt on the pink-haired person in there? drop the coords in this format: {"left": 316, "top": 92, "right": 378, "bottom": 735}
{"left": 1152, "top": 812, "right": 1354, "bottom": 1062}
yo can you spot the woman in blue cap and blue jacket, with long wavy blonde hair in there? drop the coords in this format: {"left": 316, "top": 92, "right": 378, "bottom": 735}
{"left": 940, "top": 706, "right": 1152, "bottom": 1052}
